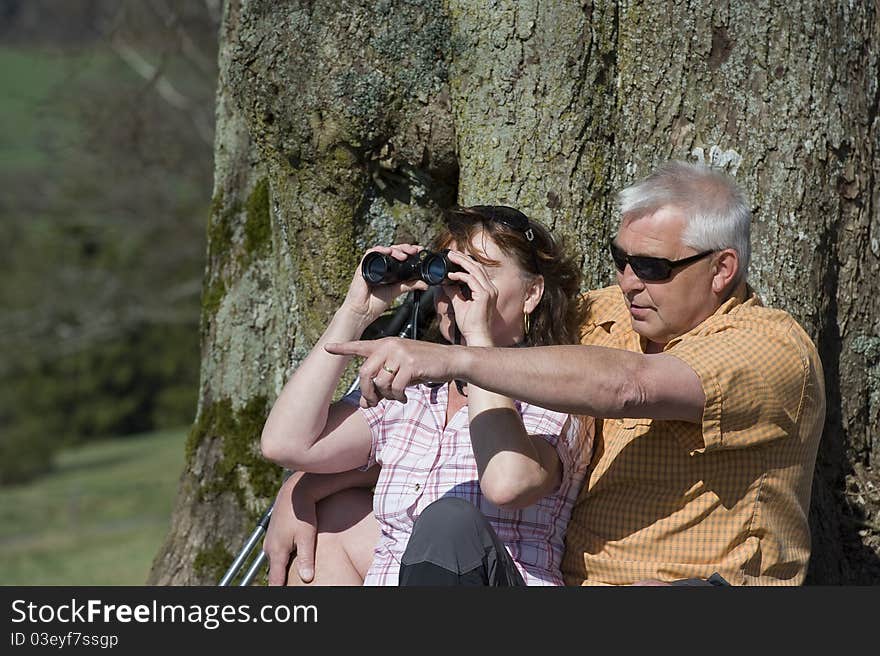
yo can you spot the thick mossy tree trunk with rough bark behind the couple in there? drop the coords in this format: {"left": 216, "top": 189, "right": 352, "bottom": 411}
{"left": 151, "top": 0, "right": 880, "bottom": 584}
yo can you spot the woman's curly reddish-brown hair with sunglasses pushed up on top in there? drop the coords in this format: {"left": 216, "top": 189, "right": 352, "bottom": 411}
{"left": 434, "top": 205, "right": 585, "bottom": 346}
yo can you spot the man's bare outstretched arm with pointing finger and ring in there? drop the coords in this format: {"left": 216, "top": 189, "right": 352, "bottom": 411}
{"left": 325, "top": 338, "right": 706, "bottom": 423}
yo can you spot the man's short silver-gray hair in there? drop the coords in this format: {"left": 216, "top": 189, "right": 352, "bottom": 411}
{"left": 617, "top": 161, "right": 752, "bottom": 282}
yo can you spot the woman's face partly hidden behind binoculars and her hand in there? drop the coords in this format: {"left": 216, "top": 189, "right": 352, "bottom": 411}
{"left": 434, "top": 232, "right": 537, "bottom": 346}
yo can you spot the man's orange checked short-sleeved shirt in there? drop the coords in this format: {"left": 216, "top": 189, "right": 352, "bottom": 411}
{"left": 562, "top": 285, "right": 825, "bottom": 585}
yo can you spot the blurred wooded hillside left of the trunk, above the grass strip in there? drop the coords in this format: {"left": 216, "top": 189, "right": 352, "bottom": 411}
{"left": 0, "top": 0, "right": 220, "bottom": 484}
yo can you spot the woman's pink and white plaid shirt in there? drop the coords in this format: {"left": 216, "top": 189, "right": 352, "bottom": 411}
{"left": 345, "top": 385, "right": 593, "bottom": 585}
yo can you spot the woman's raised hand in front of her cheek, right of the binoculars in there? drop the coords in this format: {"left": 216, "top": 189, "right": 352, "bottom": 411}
{"left": 444, "top": 250, "right": 498, "bottom": 346}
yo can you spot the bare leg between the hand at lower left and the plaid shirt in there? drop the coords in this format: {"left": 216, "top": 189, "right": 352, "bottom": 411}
{"left": 287, "top": 488, "right": 379, "bottom": 585}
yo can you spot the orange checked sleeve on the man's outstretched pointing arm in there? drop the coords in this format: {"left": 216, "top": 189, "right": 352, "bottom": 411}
{"left": 667, "top": 321, "right": 809, "bottom": 453}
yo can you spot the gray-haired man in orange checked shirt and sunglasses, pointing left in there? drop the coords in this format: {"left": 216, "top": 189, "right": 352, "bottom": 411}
{"left": 266, "top": 162, "right": 825, "bottom": 585}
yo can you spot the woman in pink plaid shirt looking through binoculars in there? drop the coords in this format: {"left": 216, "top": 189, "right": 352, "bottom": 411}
{"left": 262, "top": 206, "right": 592, "bottom": 585}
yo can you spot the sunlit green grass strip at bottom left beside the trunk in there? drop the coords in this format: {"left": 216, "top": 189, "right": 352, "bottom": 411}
{"left": 0, "top": 429, "right": 186, "bottom": 585}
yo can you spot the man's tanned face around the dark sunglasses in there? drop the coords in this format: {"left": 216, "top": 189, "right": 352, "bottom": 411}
{"left": 614, "top": 206, "right": 718, "bottom": 350}
